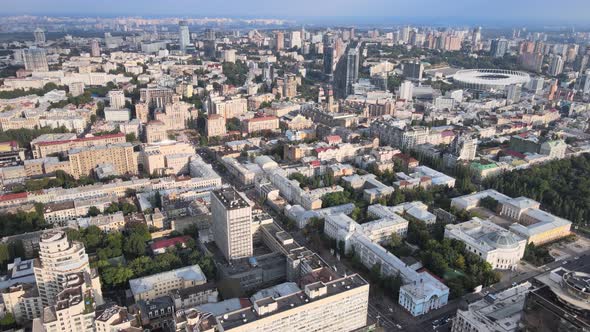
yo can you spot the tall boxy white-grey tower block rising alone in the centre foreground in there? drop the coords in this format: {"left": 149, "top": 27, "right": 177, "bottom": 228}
{"left": 211, "top": 188, "right": 253, "bottom": 261}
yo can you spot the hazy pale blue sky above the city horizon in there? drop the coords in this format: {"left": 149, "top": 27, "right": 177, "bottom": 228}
{"left": 0, "top": 0, "right": 590, "bottom": 24}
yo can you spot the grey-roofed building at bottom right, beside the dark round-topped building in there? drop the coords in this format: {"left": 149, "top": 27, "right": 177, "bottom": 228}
{"left": 451, "top": 282, "right": 532, "bottom": 332}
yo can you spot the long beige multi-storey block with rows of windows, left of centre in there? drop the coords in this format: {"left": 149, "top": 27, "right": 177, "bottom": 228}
{"left": 68, "top": 143, "right": 137, "bottom": 179}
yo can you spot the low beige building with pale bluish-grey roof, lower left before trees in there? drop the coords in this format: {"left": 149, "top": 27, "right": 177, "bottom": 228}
{"left": 129, "top": 265, "right": 212, "bottom": 303}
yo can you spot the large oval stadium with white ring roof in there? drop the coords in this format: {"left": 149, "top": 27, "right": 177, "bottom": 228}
{"left": 453, "top": 69, "right": 531, "bottom": 91}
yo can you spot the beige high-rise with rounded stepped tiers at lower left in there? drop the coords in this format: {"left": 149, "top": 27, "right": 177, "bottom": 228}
{"left": 34, "top": 230, "right": 102, "bottom": 306}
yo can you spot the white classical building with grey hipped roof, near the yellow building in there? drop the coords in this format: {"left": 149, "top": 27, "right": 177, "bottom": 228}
{"left": 445, "top": 217, "right": 527, "bottom": 270}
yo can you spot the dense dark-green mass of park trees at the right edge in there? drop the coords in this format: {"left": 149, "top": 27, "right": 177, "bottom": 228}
{"left": 483, "top": 154, "right": 590, "bottom": 224}
